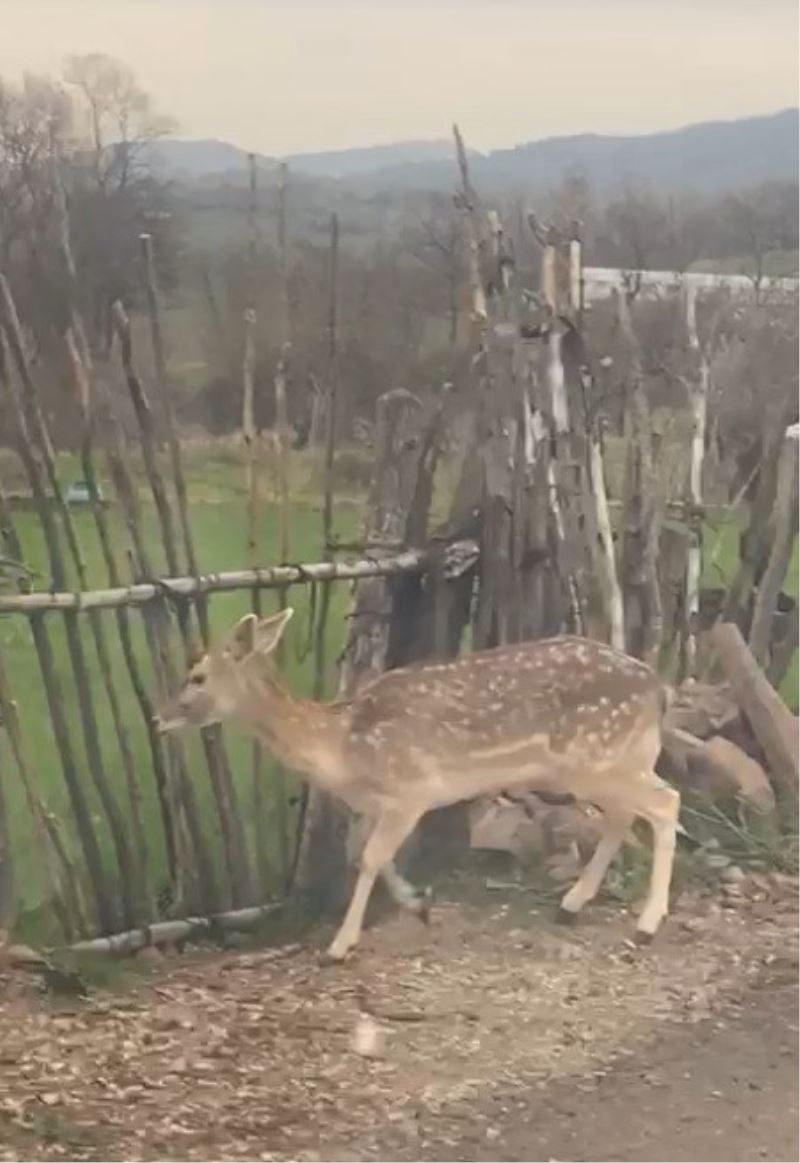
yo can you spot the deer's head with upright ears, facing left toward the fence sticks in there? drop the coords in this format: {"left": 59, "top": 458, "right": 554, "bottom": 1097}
{"left": 156, "top": 607, "right": 293, "bottom": 734}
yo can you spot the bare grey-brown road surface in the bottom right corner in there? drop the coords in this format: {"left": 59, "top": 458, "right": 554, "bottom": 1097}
{"left": 376, "top": 984, "right": 800, "bottom": 1163}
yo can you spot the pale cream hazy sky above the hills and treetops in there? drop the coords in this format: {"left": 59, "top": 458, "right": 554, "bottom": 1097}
{"left": 0, "top": 0, "right": 798, "bottom": 155}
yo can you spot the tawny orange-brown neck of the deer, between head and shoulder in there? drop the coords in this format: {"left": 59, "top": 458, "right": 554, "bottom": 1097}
{"left": 227, "top": 668, "right": 347, "bottom": 791}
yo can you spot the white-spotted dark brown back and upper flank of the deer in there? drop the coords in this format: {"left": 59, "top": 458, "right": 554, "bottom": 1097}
{"left": 347, "top": 636, "right": 663, "bottom": 786}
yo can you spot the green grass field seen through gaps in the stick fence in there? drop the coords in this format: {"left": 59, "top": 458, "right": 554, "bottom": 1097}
{"left": 0, "top": 444, "right": 798, "bottom": 932}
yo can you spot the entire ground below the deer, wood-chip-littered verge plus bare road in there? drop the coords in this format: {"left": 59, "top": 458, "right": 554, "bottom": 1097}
{"left": 0, "top": 875, "right": 798, "bottom": 1161}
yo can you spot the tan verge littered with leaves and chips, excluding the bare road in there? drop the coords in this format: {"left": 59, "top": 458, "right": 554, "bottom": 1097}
{"left": 0, "top": 879, "right": 797, "bottom": 1161}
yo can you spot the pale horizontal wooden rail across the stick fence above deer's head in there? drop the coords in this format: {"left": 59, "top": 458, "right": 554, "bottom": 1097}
{"left": 0, "top": 550, "right": 428, "bottom": 614}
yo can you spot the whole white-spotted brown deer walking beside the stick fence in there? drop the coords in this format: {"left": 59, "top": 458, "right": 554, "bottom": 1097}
{"left": 157, "top": 607, "right": 683, "bottom": 962}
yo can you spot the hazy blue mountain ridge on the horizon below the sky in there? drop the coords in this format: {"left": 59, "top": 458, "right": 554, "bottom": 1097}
{"left": 151, "top": 109, "right": 800, "bottom": 194}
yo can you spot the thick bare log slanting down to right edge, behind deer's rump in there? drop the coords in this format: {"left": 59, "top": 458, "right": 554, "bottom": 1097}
{"left": 712, "top": 622, "right": 800, "bottom": 798}
